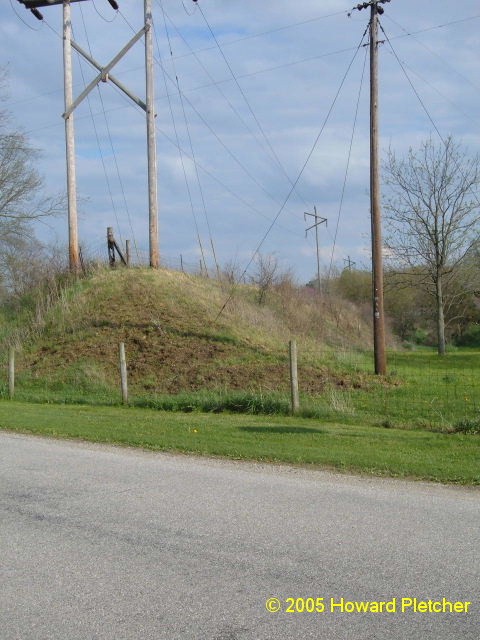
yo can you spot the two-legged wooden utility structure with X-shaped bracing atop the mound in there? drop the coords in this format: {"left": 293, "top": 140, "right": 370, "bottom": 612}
{"left": 18, "top": 0, "right": 160, "bottom": 273}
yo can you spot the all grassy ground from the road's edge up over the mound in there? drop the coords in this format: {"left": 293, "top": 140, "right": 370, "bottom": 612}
{"left": 0, "top": 269, "right": 480, "bottom": 484}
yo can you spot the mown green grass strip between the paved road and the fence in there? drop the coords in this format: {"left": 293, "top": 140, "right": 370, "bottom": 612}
{"left": 0, "top": 400, "right": 480, "bottom": 485}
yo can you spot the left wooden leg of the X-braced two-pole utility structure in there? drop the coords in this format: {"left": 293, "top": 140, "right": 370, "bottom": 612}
{"left": 63, "top": 0, "right": 80, "bottom": 273}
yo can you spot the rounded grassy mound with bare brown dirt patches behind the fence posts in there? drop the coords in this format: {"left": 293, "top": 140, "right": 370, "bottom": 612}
{"left": 3, "top": 269, "right": 376, "bottom": 394}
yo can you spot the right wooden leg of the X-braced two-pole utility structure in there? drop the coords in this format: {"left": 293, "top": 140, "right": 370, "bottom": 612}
{"left": 144, "top": 0, "right": 160, "bottom": 269}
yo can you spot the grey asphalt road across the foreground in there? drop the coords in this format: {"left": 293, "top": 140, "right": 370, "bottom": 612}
{"left": 0, "top": 433, "right": 480, "bottom": 640}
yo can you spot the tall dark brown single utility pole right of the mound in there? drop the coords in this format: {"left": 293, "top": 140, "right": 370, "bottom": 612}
{"left": 370, "top": 0, "right": 387, "bottom": 375}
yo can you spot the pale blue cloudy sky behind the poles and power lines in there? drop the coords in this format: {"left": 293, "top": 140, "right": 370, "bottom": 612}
{"left": 0, "top": 0, "right": 480, "bottom": 282}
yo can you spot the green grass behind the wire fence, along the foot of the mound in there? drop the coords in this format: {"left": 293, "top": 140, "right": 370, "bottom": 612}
{"left": 6, "top": 345, "right": 480, "bottom": 431}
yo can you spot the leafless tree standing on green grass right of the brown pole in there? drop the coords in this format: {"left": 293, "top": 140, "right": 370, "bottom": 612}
{"left": 384, "top": 137, "right": 480, "bottom": 355}
